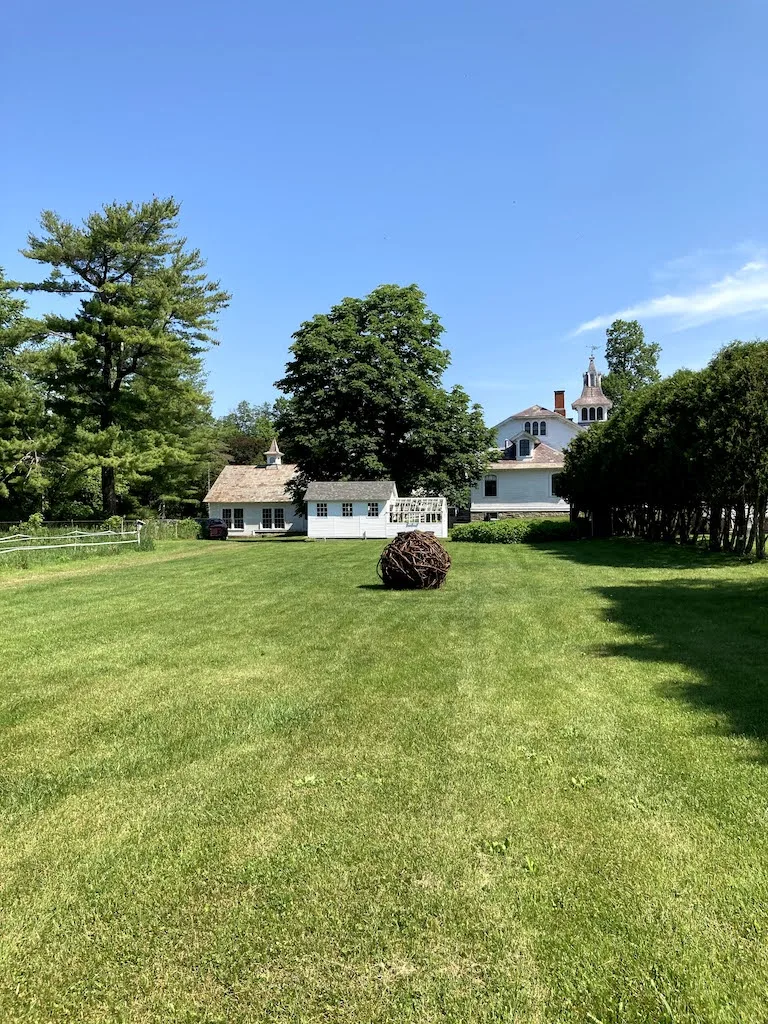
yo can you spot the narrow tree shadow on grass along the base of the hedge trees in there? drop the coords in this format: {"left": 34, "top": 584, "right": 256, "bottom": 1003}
{"left": 537, "top": 538, "right": 745, "bottom": 569}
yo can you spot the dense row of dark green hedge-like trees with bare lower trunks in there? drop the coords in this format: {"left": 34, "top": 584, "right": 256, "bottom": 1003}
{"left": 558, "top": 341, "right": 768, "bottom": 558}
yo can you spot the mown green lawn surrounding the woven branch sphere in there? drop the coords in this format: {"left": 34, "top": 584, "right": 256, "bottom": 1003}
{"left": 0, "top": 542, "right": 768, "bottom": 1024}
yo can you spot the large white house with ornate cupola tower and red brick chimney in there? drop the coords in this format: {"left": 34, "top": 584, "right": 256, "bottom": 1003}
{"left": 470, "top": 358, "right": 612, "bottom": 520}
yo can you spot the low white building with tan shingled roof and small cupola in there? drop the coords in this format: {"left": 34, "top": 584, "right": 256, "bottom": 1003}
{"left": 205, "top": 440, "right": 306, "bottom": 537}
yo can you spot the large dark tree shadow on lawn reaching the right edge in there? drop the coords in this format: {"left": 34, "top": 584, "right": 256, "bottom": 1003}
{"left": 595, "top": 566, "right": 768, "bottom": 741}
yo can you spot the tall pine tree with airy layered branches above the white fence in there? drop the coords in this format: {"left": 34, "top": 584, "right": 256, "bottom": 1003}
{"left": 15, "top": 198, "right": 229, "bottom": 515}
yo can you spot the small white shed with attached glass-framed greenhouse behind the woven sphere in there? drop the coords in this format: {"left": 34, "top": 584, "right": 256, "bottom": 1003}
{"left": 305, "top": 480, "right": 447, "bottom": 540}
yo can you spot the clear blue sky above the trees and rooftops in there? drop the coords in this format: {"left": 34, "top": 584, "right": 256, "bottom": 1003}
{"left": 0, "top": 0, "right": 768, "bottom": 423}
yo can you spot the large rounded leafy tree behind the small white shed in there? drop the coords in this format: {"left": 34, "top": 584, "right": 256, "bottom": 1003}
{"left": 275, "top": 285, "right": 494, "bottom": 503}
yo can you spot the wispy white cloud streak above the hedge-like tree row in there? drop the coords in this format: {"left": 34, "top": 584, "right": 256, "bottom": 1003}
{"left": 573, "top": 247, "right": 768, "bottom": 334}
